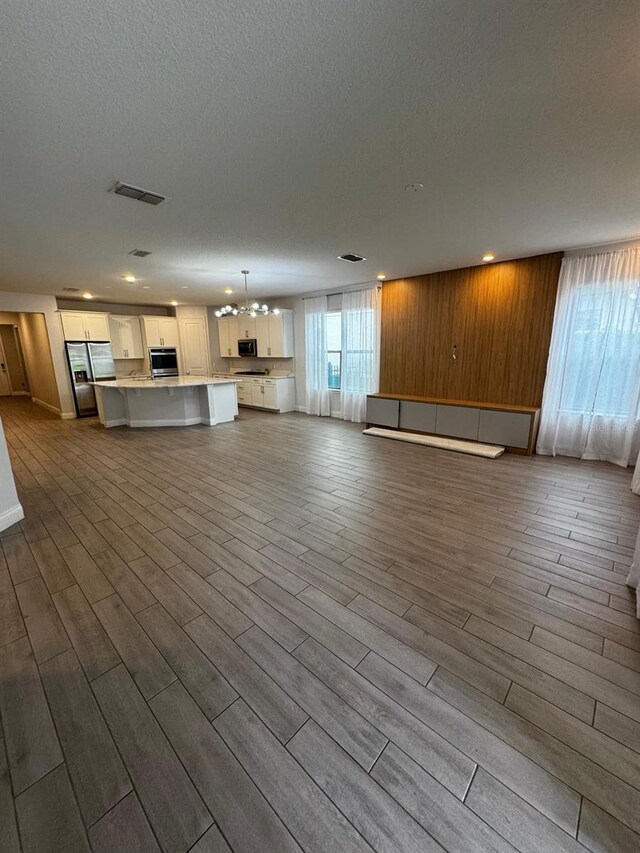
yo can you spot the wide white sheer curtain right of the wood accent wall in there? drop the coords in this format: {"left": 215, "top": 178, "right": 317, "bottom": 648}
{"left": 537, "top": 249, "right": 640, "bottom": 466}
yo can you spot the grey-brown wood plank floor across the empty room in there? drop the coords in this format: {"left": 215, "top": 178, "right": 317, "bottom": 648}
{"left": 0, "top": 399, "right": 640, "bottom": 853}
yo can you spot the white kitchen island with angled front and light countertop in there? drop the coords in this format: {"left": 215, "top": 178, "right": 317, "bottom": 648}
{"left": 92, "top": 376, "right": 238, "bottom": 427}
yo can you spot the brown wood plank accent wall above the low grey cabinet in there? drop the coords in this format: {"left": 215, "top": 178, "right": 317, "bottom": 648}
{"left": 380, "top": 252, "right": 562, "bottom": 406}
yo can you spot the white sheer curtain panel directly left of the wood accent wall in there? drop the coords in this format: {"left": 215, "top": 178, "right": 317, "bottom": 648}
{"left": 340, "top": 287, "right": 380, "bottom": 423}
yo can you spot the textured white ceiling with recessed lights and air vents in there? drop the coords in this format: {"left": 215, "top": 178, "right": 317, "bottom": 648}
{"left": 0, "top": 0, "right": 640, "bottom": 306}
